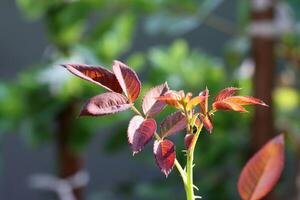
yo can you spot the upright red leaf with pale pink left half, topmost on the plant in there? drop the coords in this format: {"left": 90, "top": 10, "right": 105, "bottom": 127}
{"left": 113, "top": 60, "right": 141, "bottom": 102}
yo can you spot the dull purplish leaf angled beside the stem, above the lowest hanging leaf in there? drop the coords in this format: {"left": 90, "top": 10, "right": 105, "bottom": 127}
{"left": 160, "top": 111, "right": 186, "bottom": 137}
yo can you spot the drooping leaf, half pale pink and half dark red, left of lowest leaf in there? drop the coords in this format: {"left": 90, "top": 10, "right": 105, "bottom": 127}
{"left": 127, "top": 115, "right": 156, "bottom": 155}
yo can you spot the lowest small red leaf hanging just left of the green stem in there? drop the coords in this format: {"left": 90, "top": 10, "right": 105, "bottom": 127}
{"left": 153, "top": 140, "right": 176, "bottom": 177}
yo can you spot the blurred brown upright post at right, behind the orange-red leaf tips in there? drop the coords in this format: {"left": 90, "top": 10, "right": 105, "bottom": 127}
{"left": 251, "top": 0, "right": 276, "bottom": 200}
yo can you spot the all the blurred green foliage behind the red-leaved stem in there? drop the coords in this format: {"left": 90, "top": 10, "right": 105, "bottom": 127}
{"left": 0, "top": 0, "right": 300, "bottom": 199}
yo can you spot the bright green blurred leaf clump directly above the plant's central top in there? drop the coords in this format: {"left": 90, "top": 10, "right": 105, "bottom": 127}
{"left": 149, "top": 40, "right": 225, "bottom": 92}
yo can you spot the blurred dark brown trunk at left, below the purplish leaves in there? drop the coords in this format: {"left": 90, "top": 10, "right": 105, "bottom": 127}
{"left": 56, "top": 102, "right": 83, "bottom": 200}
